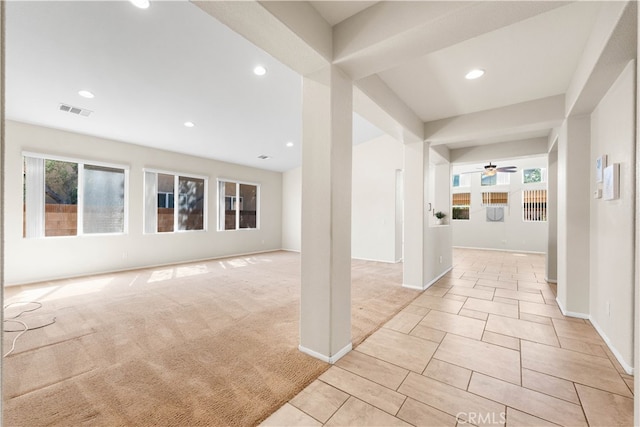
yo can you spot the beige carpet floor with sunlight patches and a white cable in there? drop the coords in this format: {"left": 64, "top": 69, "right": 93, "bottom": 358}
{"left": 2, "top": 252, "right": 418, "bottom": 426}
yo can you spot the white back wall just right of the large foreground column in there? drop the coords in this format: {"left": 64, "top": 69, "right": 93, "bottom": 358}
{"left": 351, "top": 135, "right": 402, "bottom": 262}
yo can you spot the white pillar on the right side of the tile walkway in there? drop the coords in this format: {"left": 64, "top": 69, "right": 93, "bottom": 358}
{"left": 557, "top": 115, "right": 591, "bottom": 317}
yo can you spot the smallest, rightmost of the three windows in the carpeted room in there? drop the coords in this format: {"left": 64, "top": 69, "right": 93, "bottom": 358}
{"left": 218, "top": 181, "right": 260, "bottom": 231}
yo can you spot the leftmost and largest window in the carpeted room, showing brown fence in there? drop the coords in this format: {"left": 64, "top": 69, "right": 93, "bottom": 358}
{"left": 23, "top": 154, "right": 129, "bottom": 238}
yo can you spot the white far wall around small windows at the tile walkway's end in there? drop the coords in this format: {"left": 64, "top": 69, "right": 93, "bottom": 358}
{"left": 451, "top": 157, "right": 547, "bottom": 253}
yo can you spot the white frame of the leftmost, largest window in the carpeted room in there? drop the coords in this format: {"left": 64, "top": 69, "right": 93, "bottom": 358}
{"left": 21, "top": 151, "right": 130, "bottom": 239}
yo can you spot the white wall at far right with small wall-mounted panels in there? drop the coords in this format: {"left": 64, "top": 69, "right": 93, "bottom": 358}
{"left": 589, "top": 61, "right": 636, "bottom": 372}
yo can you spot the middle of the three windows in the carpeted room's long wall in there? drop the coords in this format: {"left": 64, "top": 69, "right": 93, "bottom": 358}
{"left": 144, "top": 170, "right": 207, "bottom": 233}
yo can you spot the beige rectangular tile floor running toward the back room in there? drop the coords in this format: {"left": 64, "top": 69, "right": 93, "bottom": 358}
{"left": 262, "top": 249, "right": 633, "bottom": 426}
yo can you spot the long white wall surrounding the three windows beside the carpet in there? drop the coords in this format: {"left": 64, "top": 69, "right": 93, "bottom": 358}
{"left": 3, "top": 121, "right": 282, "bottom": 285}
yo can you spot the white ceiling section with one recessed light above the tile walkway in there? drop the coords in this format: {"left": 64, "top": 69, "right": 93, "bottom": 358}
{"left": 379, "top": 1, "right": 600, "bottom": 122}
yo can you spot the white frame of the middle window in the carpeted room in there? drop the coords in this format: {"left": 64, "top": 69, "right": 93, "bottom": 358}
{"left": 142, "top": 168, "right": 209, "bottom": 235}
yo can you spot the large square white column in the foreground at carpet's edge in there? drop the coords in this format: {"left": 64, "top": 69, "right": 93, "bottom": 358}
{"left": 299, "top": 66, "right": 353, "bottom": 363}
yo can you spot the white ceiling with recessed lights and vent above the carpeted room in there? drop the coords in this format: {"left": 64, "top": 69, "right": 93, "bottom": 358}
{"left": 6, "top": 1, "right": 382, "bottom": 171}
